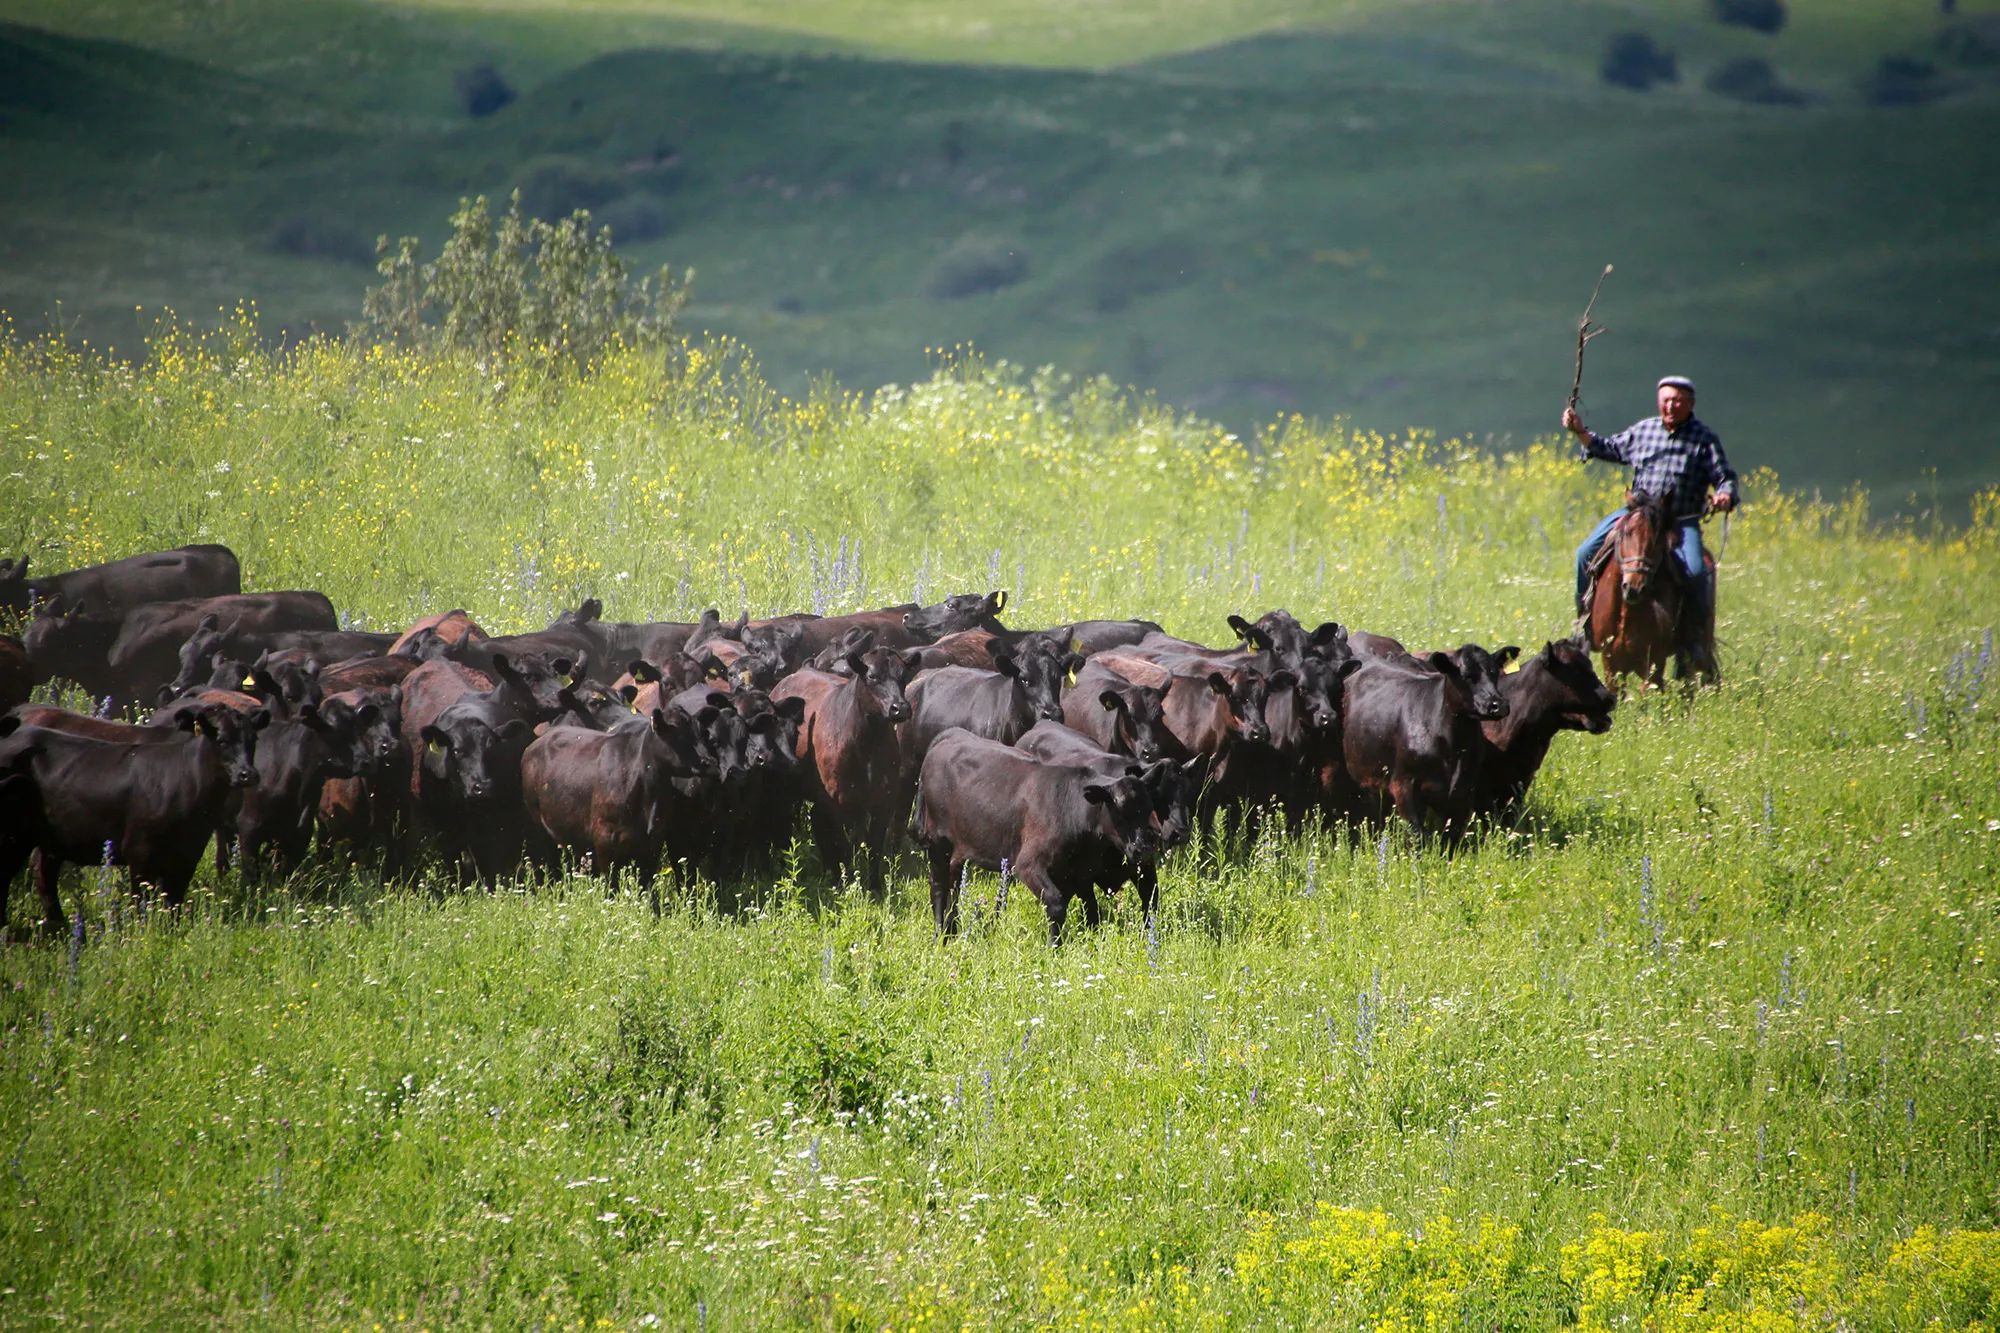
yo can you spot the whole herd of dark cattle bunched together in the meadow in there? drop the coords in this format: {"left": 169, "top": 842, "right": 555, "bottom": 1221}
{"left": 0, "top": 546, "right": 1614, "bottom": 937}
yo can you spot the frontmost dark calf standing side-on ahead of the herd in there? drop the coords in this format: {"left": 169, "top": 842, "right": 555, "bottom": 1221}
{"left": 910, "top": 729, "right": 1160, "bottom": 945}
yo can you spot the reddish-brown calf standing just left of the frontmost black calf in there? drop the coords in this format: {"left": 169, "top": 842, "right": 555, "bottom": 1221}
{"left": 770, "top": 648, "right": 916, "bottom": 889}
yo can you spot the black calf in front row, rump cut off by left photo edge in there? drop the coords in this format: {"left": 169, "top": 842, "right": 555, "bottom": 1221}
{"left": 0, "top": 707, "right": 268, "bottom": 935}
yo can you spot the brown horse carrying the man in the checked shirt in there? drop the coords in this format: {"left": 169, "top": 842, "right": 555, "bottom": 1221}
{"left": 1590, "top": 492, "right": 1716, "bottom": 691}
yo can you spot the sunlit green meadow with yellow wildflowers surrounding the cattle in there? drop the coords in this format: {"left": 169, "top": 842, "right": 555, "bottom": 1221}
{"left": 0, "top": 314, "right": 2000, "bottom": 1329}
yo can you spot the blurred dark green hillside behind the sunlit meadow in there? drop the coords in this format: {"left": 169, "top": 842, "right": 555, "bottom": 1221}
{"left": 0, "top": 0, "right": 2000, "bottom": 516}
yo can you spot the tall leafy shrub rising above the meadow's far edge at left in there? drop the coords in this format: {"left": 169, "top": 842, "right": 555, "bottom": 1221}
{"left": 356, "top": 192, "right": 694, "bottom": 362}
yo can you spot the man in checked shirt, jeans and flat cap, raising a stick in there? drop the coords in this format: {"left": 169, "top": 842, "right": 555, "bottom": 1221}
{"left": 1562, "top": 374, "right": 1740, "bottom": 677}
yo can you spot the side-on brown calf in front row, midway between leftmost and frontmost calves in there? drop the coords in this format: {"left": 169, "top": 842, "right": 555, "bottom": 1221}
{"left": 520, "top": 709, "right": 700, "bottom": 885}
